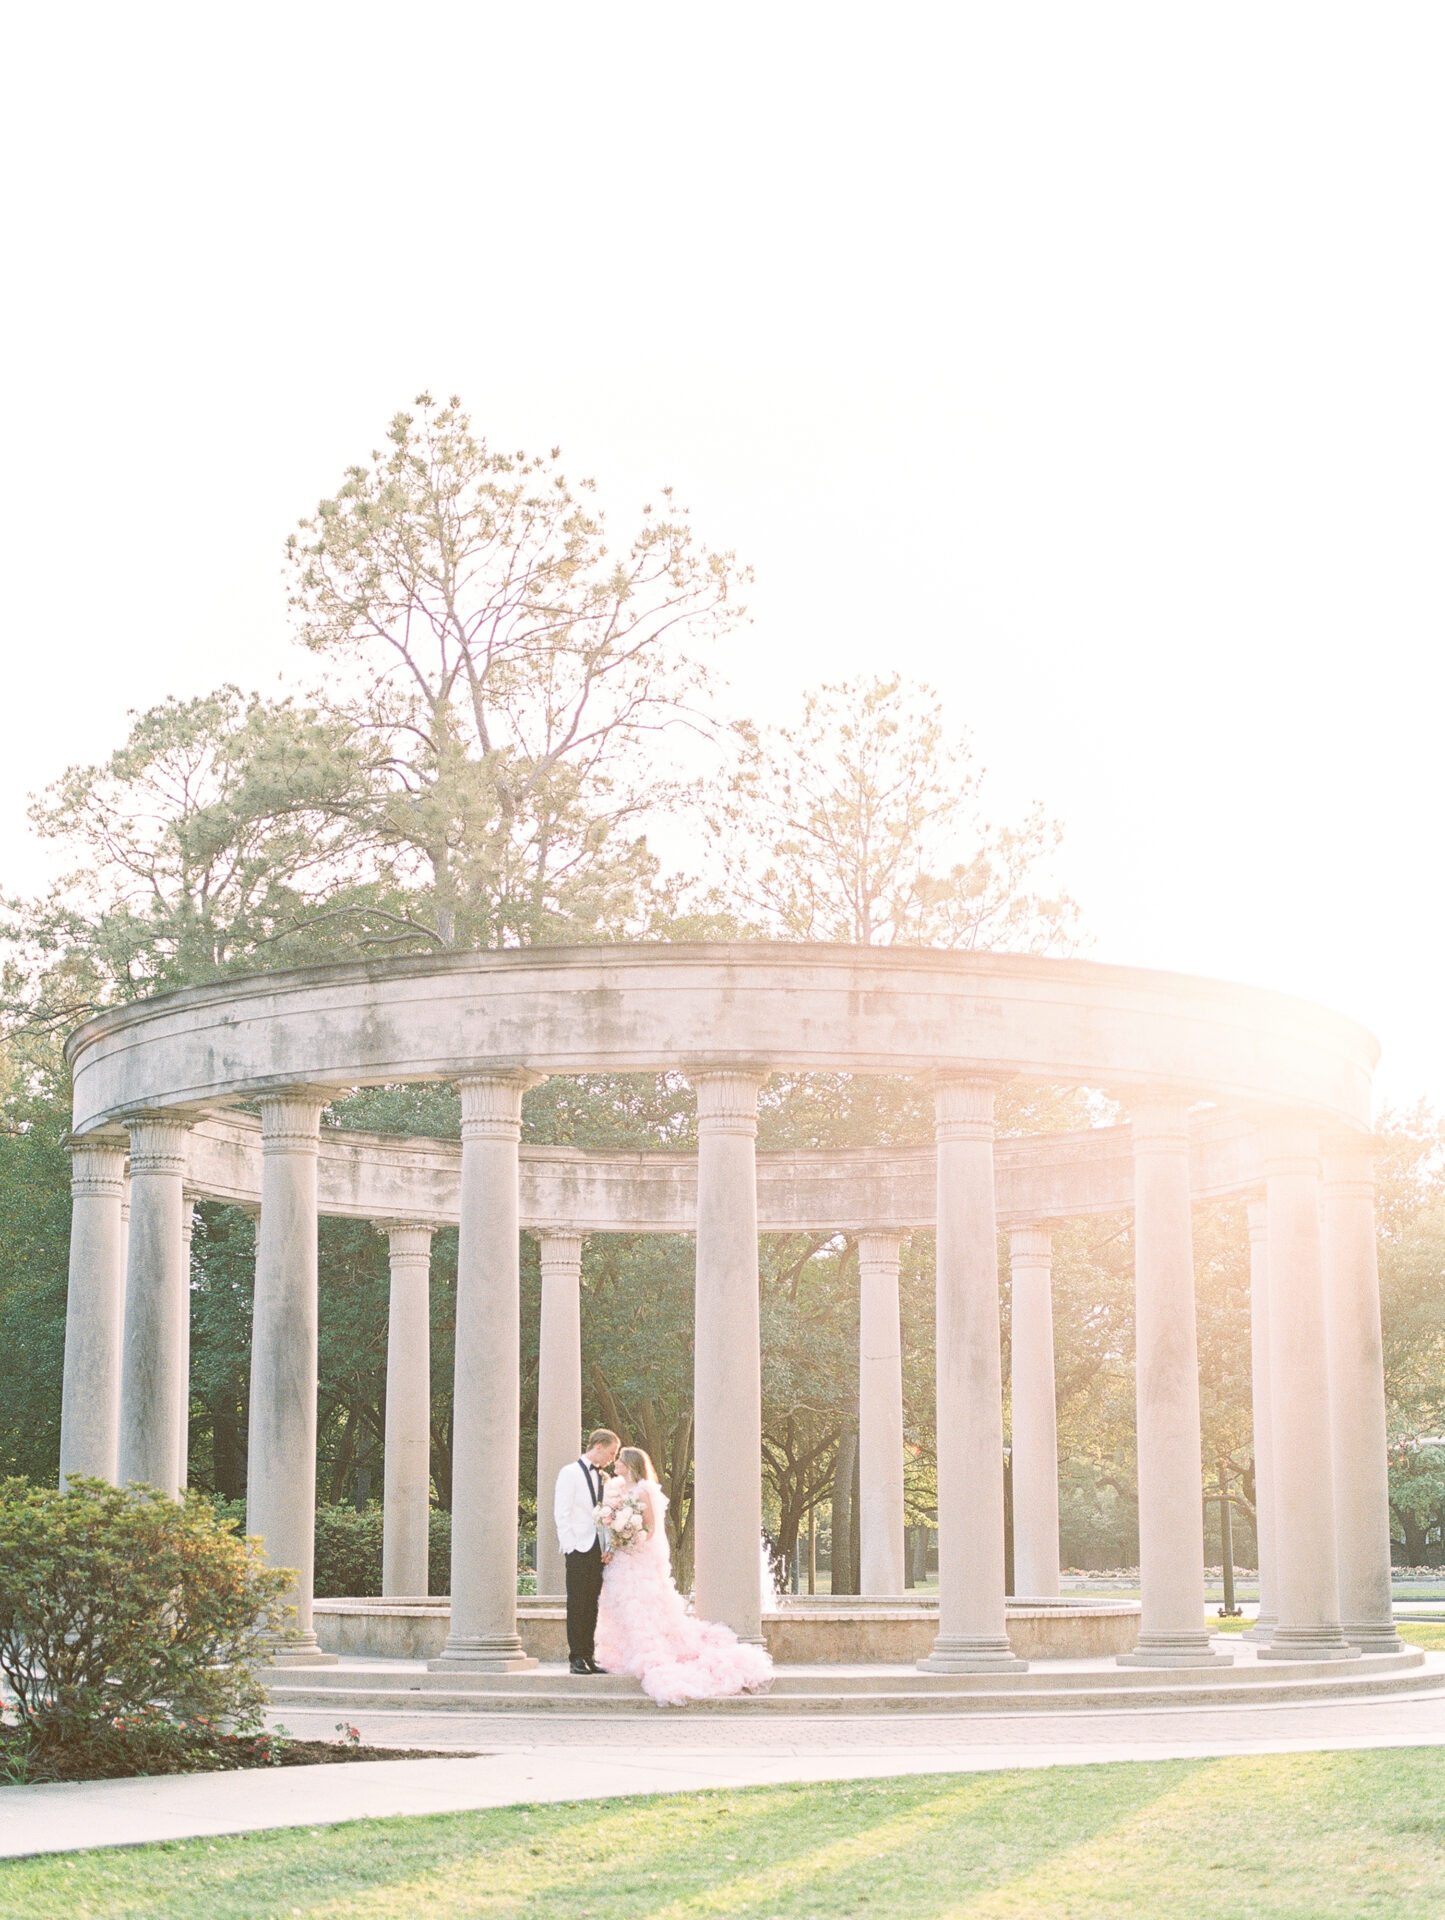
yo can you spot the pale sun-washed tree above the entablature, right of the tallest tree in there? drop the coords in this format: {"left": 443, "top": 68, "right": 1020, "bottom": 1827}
{"left": 708, "top": 676, "right": 1077, "bottom": 952}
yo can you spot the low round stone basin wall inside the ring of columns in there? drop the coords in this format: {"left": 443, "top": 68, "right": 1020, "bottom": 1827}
{"left": 315, "top": 1594, "right": 1140, "bottom": 1667}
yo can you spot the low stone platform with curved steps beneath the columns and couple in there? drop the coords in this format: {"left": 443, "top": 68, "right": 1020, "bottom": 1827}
{"left": 269, "top": 1636, "right": 1439, "bottom": 1724}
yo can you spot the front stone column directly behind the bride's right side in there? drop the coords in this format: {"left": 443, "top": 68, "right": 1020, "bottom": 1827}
{"left": 691, "top": 1068, "right": 768, "bottom": 1644}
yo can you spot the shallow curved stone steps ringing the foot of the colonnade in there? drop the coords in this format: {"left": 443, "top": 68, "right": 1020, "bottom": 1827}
{"left": 269, "top": 1661, "right": 1445, "bottom": 1718}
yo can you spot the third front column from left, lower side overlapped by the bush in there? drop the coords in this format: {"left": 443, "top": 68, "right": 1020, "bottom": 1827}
{"left": 246, "top": 1087, "right": 336, "bottom": 1665}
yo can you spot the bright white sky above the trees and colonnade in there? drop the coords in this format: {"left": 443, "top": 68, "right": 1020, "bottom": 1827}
{"left": 0, "top": 0, "right": 1445, "bottom": 1104}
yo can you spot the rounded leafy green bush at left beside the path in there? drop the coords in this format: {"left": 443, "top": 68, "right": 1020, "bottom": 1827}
{"left": 0, "top": 1478, "right": 290, "bottom": 1743}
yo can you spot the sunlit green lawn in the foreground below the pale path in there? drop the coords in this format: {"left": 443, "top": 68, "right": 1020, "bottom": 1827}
{"left": 0, "top": 1747, "right": 1445, "bottom": 1920}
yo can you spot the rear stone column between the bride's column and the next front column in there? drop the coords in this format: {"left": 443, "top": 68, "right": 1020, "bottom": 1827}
{"left": 858, "top": 1233, "right": 904, "bottom": 1594}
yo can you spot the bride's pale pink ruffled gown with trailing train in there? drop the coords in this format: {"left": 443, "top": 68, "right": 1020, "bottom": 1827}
{"left": 597, "top": 1482, "right": 773, "bottom": 1707}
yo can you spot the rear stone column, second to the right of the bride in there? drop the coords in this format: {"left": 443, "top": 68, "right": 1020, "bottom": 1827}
{"left": 1009, "top": 1227, "right": 1059, "bottom": 1597}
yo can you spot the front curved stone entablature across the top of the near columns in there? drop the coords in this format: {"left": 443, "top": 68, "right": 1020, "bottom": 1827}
{"left": 67, "top": 941, "right": 1378, "bottom": 1133}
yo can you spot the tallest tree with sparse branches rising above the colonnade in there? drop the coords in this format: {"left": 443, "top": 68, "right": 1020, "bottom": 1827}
{"left": 290, "top": 394, "right": 743, "bottom": 947}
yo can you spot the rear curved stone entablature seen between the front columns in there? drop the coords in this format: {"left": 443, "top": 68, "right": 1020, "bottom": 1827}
{"left": 168, "top": 1112, "right": 1265, "bottom": 1235}
